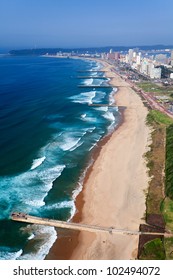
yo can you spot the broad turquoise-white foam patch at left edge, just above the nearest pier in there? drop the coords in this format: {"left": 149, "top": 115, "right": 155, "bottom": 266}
{"left": 0, "top": 164, "right": 65, "bottom": 218}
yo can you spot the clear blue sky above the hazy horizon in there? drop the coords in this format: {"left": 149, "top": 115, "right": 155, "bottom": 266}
{"left": 0, "top": 0, "right": 173, "bottom": 49}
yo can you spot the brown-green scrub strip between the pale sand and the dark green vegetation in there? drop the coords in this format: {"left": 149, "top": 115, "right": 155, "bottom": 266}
{"left": 146, "top": 110, "right": 172, "bottom": 215}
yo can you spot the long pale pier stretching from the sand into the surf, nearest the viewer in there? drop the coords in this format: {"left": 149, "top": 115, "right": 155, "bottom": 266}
{"left": 11, "top": 212, "right": 173, "bottom": 237}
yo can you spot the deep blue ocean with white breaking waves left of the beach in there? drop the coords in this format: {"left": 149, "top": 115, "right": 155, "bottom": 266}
{"left": 0, "top": 55, "right": 120, "bottom": 260}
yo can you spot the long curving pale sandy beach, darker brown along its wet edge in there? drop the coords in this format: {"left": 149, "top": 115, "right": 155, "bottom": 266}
{"left": 46, "top": 58, "right": 150, "bottom": 260}
